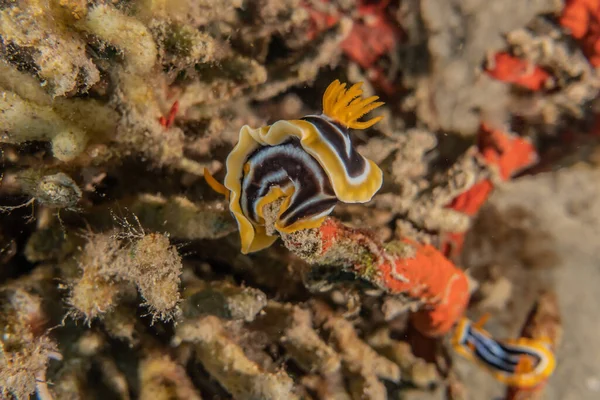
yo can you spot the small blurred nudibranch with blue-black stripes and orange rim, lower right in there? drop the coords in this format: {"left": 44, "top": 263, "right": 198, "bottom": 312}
{"left": 452, "top": 318, "right": 556, "bottom": 389}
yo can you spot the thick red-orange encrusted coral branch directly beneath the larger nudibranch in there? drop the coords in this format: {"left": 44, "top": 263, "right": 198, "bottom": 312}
{"left": 282, "top": 214, "right": 469, "bottom": 336}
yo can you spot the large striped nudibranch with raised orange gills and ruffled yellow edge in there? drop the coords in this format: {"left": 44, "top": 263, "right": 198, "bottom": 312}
{"left": 205, "top": 80, "right": 383, "bottom": 254}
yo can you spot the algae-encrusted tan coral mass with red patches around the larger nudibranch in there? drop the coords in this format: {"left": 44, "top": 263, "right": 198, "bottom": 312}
{"left": 0, "top": 0, "right": 599, "bottom": 400}
